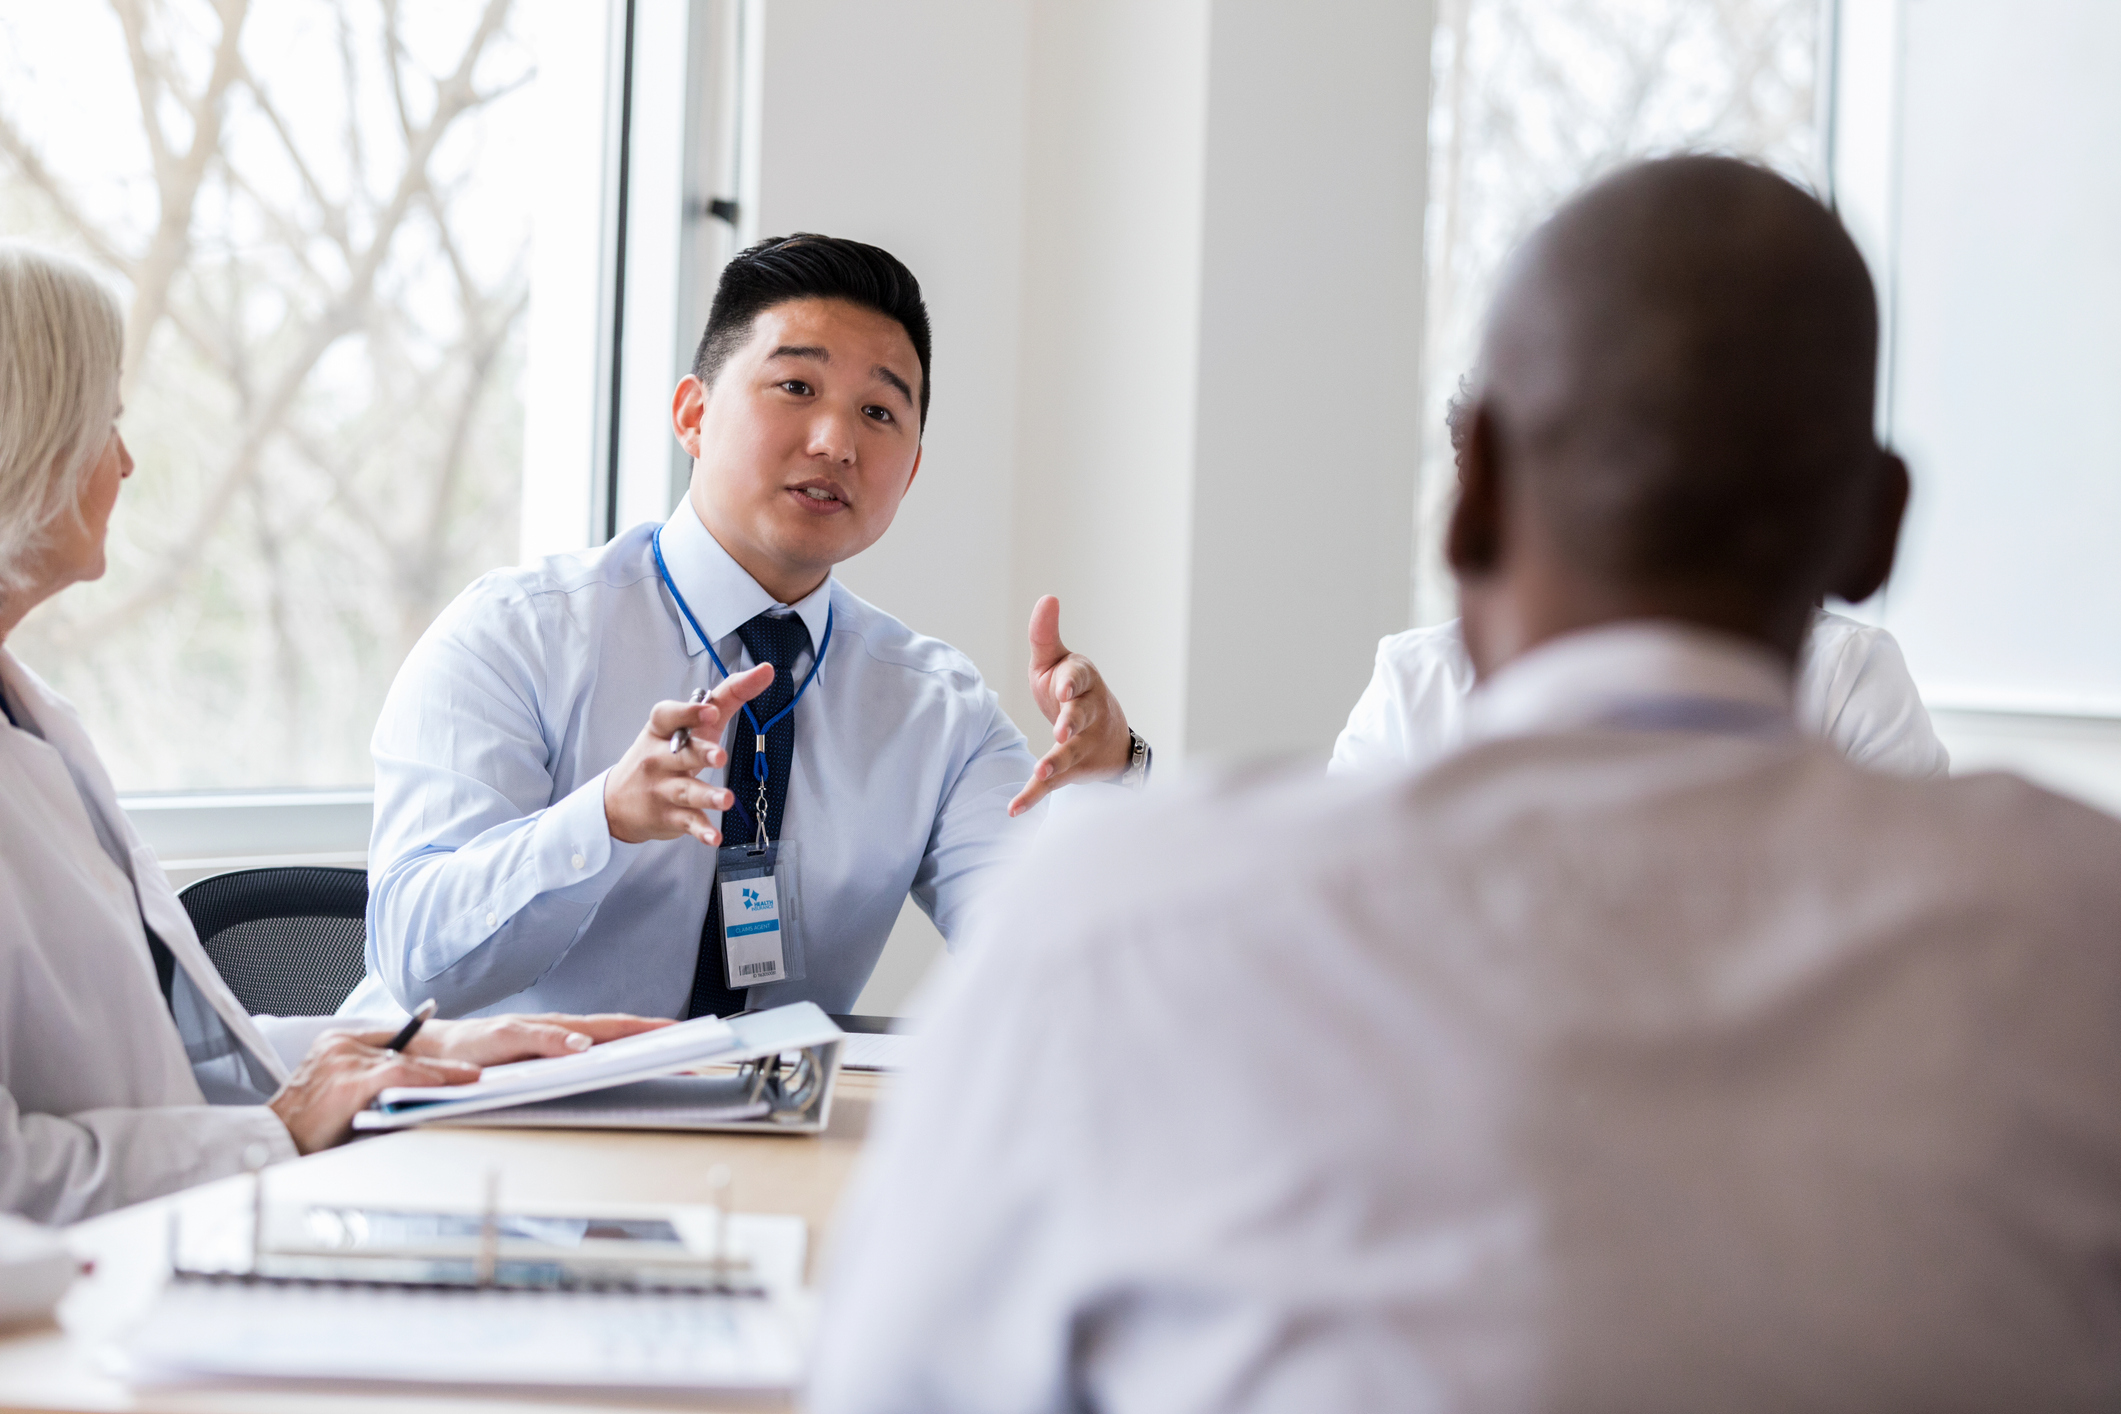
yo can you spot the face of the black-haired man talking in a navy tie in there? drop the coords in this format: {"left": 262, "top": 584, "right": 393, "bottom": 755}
{"left": 670, "top": 299, "right": 921, "bottom": 604}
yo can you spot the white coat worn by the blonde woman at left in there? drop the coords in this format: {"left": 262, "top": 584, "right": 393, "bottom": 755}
{"left": 0, "top": 649, "right": 331, "bottom": 1223}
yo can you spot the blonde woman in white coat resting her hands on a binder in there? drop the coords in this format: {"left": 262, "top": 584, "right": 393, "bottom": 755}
{"left": 0, "top": 244, "right": 660, "bottom": 1223}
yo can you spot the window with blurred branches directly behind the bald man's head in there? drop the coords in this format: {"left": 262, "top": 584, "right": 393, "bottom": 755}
{"left": 1415, "top": 0, "right": 1822, "bottom": 623}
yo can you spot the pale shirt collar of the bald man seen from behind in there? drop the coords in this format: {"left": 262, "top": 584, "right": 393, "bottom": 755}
{"left": 1466, "top": 619, "right": 1792, "bottom": 740}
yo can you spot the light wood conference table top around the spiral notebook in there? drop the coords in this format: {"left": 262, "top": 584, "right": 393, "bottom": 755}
{"left": 0, "top": 1071, "right": 887, "bottom": 1414}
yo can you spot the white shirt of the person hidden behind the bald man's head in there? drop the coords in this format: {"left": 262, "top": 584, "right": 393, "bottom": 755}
{"left": 1326, "top": 608, "right": 1951, "bottom": 778}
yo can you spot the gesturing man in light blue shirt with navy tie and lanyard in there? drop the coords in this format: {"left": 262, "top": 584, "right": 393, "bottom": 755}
{"left": 346, "top": 235, "right": 1147, "bottom": 1015}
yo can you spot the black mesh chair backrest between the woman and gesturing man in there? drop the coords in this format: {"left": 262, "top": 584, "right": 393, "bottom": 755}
{"left": 178, "top": 865, "right": 369, "bottom": 1015}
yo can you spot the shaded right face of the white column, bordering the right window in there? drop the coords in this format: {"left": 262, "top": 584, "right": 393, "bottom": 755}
{"left": 1186, "top": 0, "right": 1434, "bottom": 761}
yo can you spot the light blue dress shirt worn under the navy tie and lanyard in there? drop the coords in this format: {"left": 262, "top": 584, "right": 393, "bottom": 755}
{"left": 344, "top": 500, "right": 1039, "bottom": 1015}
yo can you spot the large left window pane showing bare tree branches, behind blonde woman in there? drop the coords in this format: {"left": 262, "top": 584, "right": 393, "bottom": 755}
{"left": 0, "top": 0, "right": 572, "bottom": 791}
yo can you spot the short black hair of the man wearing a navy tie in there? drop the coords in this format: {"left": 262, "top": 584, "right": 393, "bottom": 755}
{"left": 691, "top": 231, "right": 929, "bottom": 428}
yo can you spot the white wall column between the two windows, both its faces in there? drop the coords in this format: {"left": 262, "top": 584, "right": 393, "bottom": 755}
{"left": 1012, "top": 0, "right": 1432, "bottom": 767}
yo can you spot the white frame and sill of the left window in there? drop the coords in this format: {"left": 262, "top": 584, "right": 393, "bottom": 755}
{"left": 119, "top": 0, "right": 764, "bottom": 869}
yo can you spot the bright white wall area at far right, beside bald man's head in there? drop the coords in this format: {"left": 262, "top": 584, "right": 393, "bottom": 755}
{"left": 1835, "top": 0, "right": 2121, "bottom": 810}
